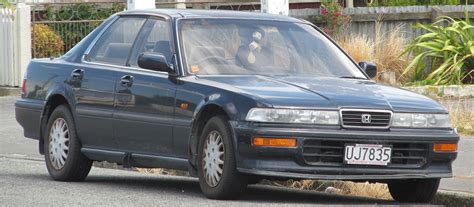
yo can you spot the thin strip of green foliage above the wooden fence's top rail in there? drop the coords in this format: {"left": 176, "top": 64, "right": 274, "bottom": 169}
{"left": 367, "top": 0, "right": 464, "bottom": 6}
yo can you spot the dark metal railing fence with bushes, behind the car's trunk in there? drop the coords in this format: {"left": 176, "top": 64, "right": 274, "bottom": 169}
{"left": 31, "top": 1, "right": 125, "bottom": 58}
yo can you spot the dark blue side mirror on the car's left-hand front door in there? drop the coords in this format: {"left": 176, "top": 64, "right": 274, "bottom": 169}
{"left": 138, "top": 53, "right": 174, "bottom": 73}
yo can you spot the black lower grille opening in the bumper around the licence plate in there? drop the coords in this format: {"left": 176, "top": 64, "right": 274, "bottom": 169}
{"left": 303, "top": 139, "right": 429, "bottom": 168}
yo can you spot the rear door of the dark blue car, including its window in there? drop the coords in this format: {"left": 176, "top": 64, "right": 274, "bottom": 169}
{"left": 77, "top": 16, "right": 146, "bottom": 149}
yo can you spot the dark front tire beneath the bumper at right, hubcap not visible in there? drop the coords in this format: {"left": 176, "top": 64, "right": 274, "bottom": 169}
{"left": 388, "top": 178, "right": 440, "bottom": 203}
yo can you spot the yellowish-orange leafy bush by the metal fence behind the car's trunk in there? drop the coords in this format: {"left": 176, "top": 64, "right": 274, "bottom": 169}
{"left": 31, "top": 24, "right": 64, "bottom": 58}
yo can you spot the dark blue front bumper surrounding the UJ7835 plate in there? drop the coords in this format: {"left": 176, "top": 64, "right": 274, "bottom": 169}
{"left": 232, "top": 122, "right": 459, "bottom": 180}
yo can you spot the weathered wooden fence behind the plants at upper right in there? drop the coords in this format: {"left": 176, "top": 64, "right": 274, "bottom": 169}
{"left": 290, "top": 5, "right": 474, "bottom": 40}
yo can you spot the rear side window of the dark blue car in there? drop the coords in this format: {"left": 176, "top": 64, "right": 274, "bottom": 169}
{"left": 89, "top": 17, "right": 146, "bottom": 66}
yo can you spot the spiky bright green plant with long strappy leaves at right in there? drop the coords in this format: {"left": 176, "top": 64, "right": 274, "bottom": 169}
{"left": 403, "top": 10, "right": 474, "bottom": 85}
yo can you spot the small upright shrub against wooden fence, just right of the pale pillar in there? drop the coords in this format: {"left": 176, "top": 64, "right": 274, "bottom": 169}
{"left": 320, "top": 0, "right": 350, "bottom": 38}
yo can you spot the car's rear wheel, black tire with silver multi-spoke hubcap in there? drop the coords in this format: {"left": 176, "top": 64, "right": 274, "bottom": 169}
{"left": 44, "top": 105, "right": 92, "bottom": 181}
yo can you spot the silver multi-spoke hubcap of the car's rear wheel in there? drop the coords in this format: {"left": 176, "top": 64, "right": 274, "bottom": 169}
{"left": 49, "top": 118, "right": 69, "bottom": 170}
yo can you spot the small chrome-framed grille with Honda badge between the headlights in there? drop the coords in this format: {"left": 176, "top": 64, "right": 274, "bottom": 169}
{"left": 341, "top": 109, "right": 392, "bottom": 128}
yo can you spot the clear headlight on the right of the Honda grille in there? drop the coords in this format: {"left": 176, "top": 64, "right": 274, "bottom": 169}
{"left": 392, "top": 113, "right": 451, "bottom": 128}
